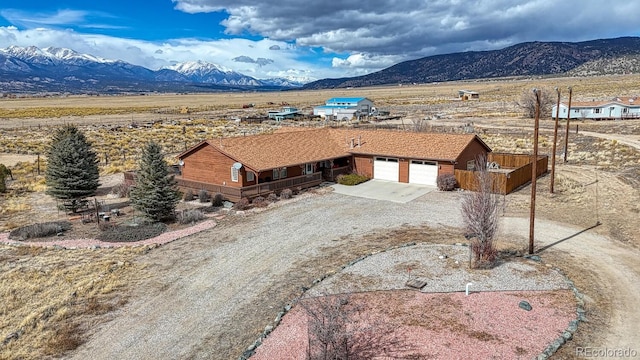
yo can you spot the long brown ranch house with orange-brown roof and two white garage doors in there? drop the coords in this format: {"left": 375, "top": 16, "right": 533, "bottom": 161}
{"left": 177, "top": 128, "right": 491, "bottom": 201}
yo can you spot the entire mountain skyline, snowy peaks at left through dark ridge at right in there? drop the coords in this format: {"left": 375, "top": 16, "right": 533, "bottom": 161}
{"left": 0, "top": 37, "right": 640, "bottom": 93}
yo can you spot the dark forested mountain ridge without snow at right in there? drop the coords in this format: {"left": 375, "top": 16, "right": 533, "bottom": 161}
{"left": 303, "top": 37, "right": 640, "bottom": 89}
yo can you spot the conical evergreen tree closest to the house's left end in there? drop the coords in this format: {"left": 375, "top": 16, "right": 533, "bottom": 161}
{"left": 130, "top": 142, "right": 180, "bottom": 221}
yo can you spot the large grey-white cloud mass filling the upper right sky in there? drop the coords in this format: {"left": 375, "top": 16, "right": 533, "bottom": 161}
{"left": 173, "top": 0, "right": 640, "bottom": 63}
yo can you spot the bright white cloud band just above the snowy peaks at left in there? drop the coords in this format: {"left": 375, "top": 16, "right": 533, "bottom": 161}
{"left": 0, "top": 26, "right": 334, "bottom": 79}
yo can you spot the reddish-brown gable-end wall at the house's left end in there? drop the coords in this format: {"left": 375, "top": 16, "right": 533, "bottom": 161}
{"left": 182, "top": 145, "right": 244, "bottom": 187}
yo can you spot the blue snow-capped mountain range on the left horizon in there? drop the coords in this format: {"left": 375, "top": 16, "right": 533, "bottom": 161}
{"left": 0, "top": 46, "right": 302, "bottom": 92}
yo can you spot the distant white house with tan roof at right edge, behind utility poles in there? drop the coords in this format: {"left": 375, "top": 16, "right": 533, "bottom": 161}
{"left": 551, "top": 97, "right": 640, "bottom": 120}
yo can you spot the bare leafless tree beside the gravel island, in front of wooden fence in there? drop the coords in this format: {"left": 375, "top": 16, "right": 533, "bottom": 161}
{"left": 461, "top": 156, "right": 500, "bottom": 268}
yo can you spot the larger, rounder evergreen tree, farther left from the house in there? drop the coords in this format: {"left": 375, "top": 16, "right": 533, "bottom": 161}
{"left": 45, "top": 125, "right": 100, "bottom": 212}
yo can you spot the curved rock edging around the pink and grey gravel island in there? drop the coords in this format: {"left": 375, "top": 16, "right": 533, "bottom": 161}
{"left": 238, "top": 242, "right": 587, "bottom": 360}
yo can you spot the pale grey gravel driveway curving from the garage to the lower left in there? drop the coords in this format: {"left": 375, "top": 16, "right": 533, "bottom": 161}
{"left": 73, "top": 192, "right": 460, "bottom": 360}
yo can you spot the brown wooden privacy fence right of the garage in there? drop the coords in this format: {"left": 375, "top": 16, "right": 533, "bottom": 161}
{"left": 455, "top": 153, "right": 549, "bottom": 194}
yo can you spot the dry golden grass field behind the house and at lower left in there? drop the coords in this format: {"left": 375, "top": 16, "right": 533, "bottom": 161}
{"left": 0, "top": 75, "right": 640, "bottom": 359}
